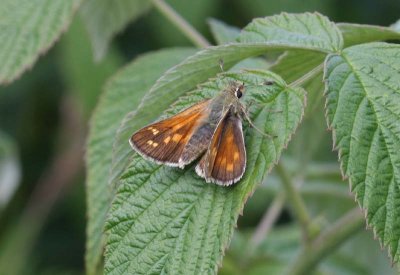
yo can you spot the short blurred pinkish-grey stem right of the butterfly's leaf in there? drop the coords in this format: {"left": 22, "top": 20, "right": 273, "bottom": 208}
{"left": 251, "top": 192, "right": 286, "bottom": 247}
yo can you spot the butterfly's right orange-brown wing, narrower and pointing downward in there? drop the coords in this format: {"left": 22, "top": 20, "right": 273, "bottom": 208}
{"left": 196, "top": 108, "right": 246, "bottom": 186}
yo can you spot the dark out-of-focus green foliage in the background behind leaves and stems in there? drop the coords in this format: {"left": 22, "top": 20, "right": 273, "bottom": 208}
{"left": 0, "top": 0, "right": 400, "bottom": 274}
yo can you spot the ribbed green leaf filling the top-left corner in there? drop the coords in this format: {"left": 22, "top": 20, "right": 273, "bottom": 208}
{"left": 0, "top": 0, "right": 80, "bottom": 84}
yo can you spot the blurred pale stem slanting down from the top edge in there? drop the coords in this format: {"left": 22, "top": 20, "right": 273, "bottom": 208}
{"left": 153, "top": 0, "right": 210, "bottom": 48}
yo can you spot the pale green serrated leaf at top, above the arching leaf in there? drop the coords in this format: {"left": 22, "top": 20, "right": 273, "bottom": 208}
{"left": 239, "top": 13, "right": 343, "bottom": 52}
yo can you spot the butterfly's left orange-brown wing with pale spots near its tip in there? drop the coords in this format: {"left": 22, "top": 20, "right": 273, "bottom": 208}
{"left": 129, "top": 100, "right": 210, "bottom": 166}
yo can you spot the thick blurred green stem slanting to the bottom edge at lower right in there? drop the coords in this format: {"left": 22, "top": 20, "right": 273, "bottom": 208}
{"left": 287, "top": 207, "right": 365, "bottom": 275}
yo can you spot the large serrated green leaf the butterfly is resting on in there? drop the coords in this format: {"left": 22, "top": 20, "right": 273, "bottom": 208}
{"left": 105, "top": 71, "right": 305, "bottom": 274}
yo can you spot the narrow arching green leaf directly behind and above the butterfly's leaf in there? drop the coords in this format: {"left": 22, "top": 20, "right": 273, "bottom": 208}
{"left": 111, "top": 43, "right": 322, "bottom": 192}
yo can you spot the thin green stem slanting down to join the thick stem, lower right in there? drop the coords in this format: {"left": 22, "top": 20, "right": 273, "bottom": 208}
{"left": 276, "top": 163, "right": 311, "bottom": 242}
